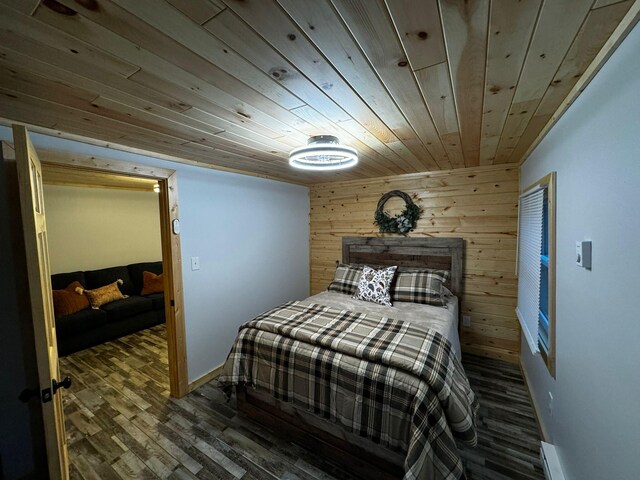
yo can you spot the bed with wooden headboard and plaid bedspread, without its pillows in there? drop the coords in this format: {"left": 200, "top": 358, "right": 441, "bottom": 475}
{"left": 218, "top": 237, "right": 478, "bottom": 480}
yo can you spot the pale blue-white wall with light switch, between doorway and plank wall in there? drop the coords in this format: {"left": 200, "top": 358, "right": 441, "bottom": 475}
{"left": 0, "top": 126, "right": 309, "bottom": 381}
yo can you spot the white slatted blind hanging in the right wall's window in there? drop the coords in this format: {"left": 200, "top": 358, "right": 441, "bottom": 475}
{"left": 516, "top": 188, "right": 544, "bottom": 353}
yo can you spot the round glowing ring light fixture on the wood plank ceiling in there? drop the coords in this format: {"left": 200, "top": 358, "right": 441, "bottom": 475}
{"left": 289, "top": 135, "right": 358, "bottom": 170}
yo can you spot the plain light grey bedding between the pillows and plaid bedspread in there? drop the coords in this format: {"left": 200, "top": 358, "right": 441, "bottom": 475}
{"left": 304, "top": 291, "right": 461, "bottom": 360}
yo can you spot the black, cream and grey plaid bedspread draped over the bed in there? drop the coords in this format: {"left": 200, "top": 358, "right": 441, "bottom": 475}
{"left": 218, "top": 302, "right": 478, "bottom": 480}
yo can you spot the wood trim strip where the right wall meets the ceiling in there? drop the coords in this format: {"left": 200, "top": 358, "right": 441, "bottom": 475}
{"left": 520, "top": 0, "right": 640, "bottom": 165}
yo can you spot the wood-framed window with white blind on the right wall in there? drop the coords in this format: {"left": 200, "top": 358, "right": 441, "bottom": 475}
{"left": 516, "top": 172, "right": 555, "bottom": 376}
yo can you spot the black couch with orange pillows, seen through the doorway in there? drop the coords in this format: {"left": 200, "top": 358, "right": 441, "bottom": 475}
{"left": 51, "top": 262, "right": 165, "bottom": 356}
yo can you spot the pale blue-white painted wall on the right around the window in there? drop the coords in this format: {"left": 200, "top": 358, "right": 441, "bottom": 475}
{"left": 520, "top": 21, "right": 640, "bottom": 480}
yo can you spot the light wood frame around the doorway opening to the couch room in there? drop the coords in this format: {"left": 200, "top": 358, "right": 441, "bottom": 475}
{"left": 20, "top": 148, "right": 189, "bottom": 398}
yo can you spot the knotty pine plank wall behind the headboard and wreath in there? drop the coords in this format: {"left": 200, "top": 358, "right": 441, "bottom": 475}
{"left": 310, "top": 164, "right": 520, "bottom": 362}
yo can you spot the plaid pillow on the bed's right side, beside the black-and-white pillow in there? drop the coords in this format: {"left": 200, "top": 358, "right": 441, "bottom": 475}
{"left": 391, "top": 269, "right": 449, "bottom": 307}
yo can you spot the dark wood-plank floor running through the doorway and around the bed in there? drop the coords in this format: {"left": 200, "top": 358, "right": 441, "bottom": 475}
{"left": 60, "top": 326, "right": 544, "bottom": 480}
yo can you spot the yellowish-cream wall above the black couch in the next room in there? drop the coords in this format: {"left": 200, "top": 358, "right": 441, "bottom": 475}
{"left": 44, "top": 185, "right": 162, "bottom": 273}
